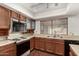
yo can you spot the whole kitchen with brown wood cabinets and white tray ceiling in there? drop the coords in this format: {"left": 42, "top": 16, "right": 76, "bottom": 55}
{"left": 0, "top": 3, "right": 79, "bottom": 56}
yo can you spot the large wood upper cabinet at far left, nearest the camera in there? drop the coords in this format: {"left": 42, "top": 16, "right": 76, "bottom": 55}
{"left": 0, "top": 6, "right": 10, "bottom": 29}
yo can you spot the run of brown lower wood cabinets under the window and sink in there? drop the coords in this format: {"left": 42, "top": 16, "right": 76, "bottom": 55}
{"left": 30, "top": 37, "right": 64, "bottom": 55}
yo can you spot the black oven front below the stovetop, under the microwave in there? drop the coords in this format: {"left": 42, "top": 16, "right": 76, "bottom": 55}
{"left": 16, "top": 40, "right": 30, "bottom": 56}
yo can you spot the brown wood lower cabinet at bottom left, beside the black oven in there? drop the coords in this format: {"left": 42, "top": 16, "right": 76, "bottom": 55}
{"left": 0, "top": 43, "right": 16, "bottom": 56}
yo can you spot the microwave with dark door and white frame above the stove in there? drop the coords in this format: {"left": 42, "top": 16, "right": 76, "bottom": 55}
{"left": 9, "top": 18, "right": 27, "bottom": 33}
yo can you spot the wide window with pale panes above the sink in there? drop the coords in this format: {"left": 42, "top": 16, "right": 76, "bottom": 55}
{"left": 40, "top": 18, "right": 68, "bottom": 34}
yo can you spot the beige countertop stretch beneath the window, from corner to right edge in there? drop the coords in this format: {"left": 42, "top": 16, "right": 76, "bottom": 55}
{"left": 33, "top": 34, "right": 79, "bottom": 41}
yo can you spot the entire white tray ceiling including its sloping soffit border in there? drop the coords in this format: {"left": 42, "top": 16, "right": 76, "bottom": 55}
{"left": 0, "top": 3, "right": 79, "bottom": 20}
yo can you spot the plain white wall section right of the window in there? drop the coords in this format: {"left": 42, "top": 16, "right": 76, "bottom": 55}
{"left": 68, "top": 15, "right": 79, "bottom": 35}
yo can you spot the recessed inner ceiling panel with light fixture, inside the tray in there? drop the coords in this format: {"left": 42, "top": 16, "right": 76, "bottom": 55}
{"left": 17, "top": 3, "right": 68, "bottom": 13}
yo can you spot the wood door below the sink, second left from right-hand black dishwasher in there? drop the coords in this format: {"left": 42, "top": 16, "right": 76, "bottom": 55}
{"left": 46, "top": 39, "right": 55, "bottom": 53}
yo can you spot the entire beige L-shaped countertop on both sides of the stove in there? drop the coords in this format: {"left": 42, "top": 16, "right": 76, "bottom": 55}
{"left": 0, "top": 34, "right": 79, "bottom": 46}
